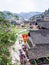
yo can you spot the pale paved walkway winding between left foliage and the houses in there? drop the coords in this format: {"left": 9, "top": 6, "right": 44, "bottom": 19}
{"left": 9, "top": 29, "right": 26, "bottom": 64}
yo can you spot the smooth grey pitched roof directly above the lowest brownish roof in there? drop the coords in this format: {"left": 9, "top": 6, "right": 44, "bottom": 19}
{"left": 30, "top": 29, "right": 49, "bottom": 44}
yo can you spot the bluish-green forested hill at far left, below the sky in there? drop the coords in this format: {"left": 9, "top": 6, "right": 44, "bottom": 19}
{"left": 0, "top": 11, "right": 19, "bottom": 19}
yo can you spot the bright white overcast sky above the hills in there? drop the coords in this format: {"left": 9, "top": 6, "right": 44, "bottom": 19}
{"left": 0, "top": 0, "right": 49, "bottom": 13}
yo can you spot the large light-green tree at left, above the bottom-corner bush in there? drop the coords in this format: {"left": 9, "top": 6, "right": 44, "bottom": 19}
{"left": 0, "top": 20, "right": 17, "bottom": 45}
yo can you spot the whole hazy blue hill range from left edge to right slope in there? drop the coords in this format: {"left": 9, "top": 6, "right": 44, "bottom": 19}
{"left": 0, "top": 11, "right": 41, "bottom": 20}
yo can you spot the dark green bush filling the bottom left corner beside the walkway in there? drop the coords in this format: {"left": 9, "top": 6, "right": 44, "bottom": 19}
{"left": 0, "top": 44, "right": 10, "bottom": 65}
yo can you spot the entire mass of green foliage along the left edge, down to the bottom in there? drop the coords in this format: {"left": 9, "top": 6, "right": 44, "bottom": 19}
{"left": 0, "top": 19, "right": 17, "bottom": 65}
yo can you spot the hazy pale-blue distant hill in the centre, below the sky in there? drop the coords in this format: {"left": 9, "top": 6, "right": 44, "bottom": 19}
{"left": 18, "top": 12, "right": 41, "bottom": 19}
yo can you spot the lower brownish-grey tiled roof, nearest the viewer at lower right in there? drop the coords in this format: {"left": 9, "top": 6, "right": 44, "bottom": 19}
{"left": 28, "top": 45, "right": 49, "bottom": 59}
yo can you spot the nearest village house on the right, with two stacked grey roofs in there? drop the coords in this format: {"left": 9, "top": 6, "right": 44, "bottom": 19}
{"left": 28, "top": 29, "right": 49, "bottom": 59}
